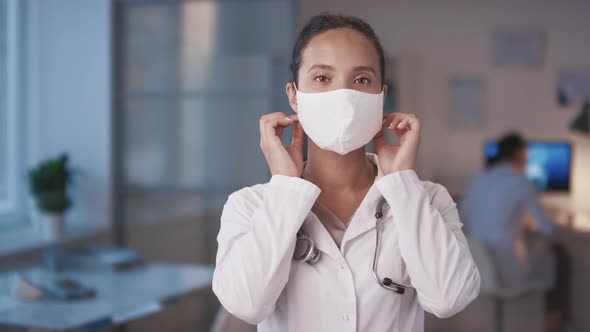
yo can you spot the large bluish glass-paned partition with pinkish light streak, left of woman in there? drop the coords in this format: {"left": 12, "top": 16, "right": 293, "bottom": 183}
{"left": 117, "top": 0, "right": 294, "bottom": 224}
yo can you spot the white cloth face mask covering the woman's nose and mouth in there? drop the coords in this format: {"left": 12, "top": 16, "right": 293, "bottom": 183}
{"left": 295, "top": 87, "right": 383, "bottom": 155}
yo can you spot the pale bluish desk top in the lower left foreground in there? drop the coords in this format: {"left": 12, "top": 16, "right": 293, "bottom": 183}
{"left": 0, "top": 264, "right": 213, "bottom": 331}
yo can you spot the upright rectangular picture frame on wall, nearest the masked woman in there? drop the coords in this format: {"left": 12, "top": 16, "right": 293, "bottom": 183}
{"left": 448, "top": 75, "right": 487, "bottom": 129}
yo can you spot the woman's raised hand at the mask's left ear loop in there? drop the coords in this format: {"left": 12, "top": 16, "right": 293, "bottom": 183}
{"left": 260, "top": 112, "right": 305, "bottom": 177}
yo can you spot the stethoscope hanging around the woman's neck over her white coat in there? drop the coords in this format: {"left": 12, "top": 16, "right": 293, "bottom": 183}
{"left": 293, "top": 198, "right": 412, "bottom": 294}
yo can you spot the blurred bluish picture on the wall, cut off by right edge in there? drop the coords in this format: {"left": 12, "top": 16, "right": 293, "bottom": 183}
{"left": 556, "top": 68, "right": 590, "bottom": 108}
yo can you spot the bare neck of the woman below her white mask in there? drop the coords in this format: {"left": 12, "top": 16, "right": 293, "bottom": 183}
{"left": 303, "top": 140, "right": 377, "bottom": 192}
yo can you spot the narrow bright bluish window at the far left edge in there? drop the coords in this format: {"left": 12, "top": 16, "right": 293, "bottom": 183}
{"left": 0, "top": 0, "right": 26, "bottom": 224}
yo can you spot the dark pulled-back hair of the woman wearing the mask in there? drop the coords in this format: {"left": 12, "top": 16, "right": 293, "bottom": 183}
{"left": 290, "top": 13, "right": 385, "bottom": 84}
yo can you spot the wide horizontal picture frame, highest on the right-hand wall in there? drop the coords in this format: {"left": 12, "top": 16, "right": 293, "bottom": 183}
{"left": 492, "top": 29, "right": 546, "bottom": 67}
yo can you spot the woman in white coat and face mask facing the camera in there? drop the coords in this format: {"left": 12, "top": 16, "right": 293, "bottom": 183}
{"left": 213, "top": 14, "right": 480, "bottom": 332}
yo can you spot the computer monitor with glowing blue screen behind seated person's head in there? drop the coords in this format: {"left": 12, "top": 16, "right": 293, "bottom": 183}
{"left": 484, "top": 141, "right": 572, "bottom": 192}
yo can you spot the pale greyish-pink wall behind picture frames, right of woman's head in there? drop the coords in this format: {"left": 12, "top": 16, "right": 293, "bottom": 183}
{"left": 298, "top": 0, "right": 590, "bottom": 195}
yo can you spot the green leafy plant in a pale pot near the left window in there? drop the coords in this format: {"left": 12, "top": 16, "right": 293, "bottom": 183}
{"left": 28, "top": 153, "right": 73, "bottom": 240}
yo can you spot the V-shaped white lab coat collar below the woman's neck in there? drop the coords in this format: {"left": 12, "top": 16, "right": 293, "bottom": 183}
{"left": 302, "top": 153, "right": 387, "bottom": 261}
